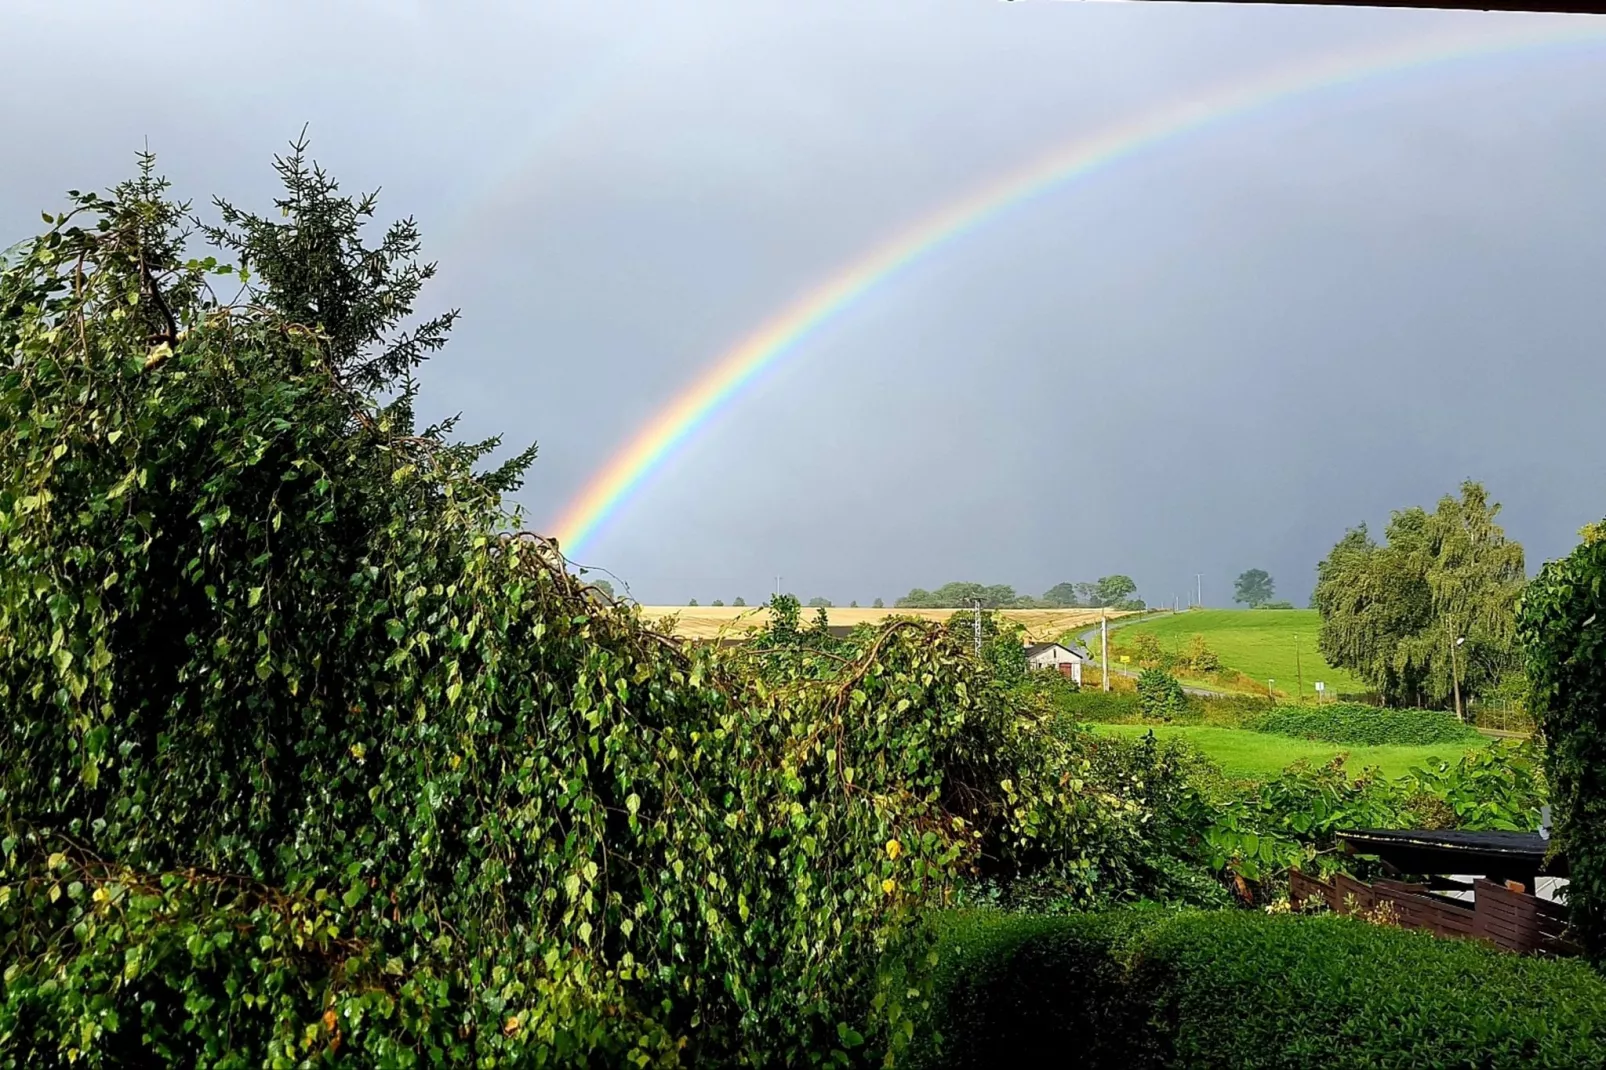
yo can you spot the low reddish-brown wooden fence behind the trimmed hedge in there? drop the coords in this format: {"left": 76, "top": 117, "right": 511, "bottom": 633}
{"left": 1288, "top": 869, "right": 1577, "bottom": 954}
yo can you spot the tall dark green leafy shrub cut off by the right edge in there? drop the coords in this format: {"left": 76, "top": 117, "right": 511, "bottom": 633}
{"left": 1518, "top": 521, "right": 1606, "bottom": 962}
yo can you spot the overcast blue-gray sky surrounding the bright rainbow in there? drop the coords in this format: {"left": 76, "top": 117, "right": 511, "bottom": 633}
{"left": 9, "top": 0, "right": 1606, "bottom": 604}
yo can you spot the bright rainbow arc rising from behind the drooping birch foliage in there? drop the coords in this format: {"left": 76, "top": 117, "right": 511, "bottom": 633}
{"left": 552, "top": 19, "right": 1606, "bottom": 559}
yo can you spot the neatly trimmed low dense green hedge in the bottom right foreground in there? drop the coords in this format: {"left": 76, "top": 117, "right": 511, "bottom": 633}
{"left": 920, "top": 911, "right": 1606, "bottom": 1070}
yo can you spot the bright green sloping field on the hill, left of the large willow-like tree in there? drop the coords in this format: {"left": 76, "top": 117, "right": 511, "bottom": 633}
{"left": 1110, "top": 609, "right": 1367, "bottom": 700}
